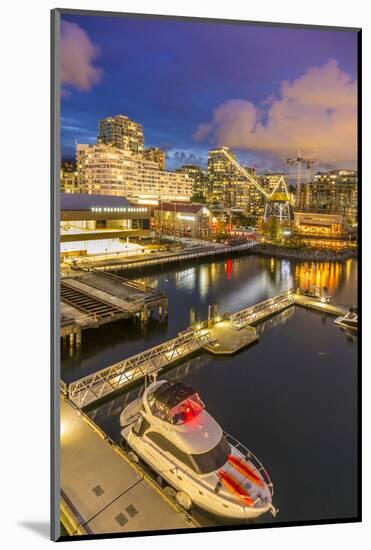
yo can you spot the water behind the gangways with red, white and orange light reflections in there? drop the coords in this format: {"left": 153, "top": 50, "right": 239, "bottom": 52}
{"left": 62, "top": 256, "right": 357, "bottom": 382}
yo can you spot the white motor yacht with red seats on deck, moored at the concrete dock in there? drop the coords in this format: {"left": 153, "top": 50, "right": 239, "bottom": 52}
{"left": 120, "top": 380, "right": 276, "bottom": 519}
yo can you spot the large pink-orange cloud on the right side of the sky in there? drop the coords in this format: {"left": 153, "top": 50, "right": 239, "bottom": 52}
{"left": 194, "top": 60, "right": 357, "bottom": 166}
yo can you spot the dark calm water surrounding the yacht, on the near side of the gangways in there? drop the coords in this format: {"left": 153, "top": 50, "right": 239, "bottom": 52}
{"left": 89, "top": 307, "right": 357, "bottom": 525}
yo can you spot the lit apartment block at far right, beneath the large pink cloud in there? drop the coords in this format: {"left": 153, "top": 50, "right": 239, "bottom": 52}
{"left": 299, "top": 170, "right": 358, "bottom": 225}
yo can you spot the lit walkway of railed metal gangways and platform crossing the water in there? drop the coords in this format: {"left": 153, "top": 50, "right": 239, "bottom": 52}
{"left": 61, "top": 289, "right": 347, "bottom": 408}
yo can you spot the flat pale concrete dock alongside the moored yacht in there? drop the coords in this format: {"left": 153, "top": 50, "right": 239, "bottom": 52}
{"left": 60, "top": 399, "right": 198, "bottom": 535}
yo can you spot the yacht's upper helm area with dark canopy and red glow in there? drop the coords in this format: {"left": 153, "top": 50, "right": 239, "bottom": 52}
{"left": 148, "top": 381, "right": 205, "bottom": 426}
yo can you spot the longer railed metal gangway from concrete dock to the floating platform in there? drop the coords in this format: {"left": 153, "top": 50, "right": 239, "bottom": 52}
{"left": 66, "top": 330, "right": 210, "bottom": 408}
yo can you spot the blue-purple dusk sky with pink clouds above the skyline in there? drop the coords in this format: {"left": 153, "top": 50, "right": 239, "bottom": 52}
{"left": 61, "top": 15, "right": 357, "bottom": 169}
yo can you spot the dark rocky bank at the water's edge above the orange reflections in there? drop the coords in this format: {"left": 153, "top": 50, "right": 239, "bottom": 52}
{"left": 251, "top": 244, "right": 358, "bottom": 262}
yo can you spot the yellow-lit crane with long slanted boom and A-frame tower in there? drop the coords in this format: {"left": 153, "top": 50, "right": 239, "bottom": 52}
{"left": 221, "top": 147, "right": 292, "bottom": 223}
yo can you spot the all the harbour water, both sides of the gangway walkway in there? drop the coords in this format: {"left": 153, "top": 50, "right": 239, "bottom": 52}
{"left": 62, "top": 256, "right": 357, "bottom": 522}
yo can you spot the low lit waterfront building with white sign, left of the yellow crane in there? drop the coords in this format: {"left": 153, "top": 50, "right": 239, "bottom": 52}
{"left": 153, "top": 202, "right": 212, "bottom": 239}
